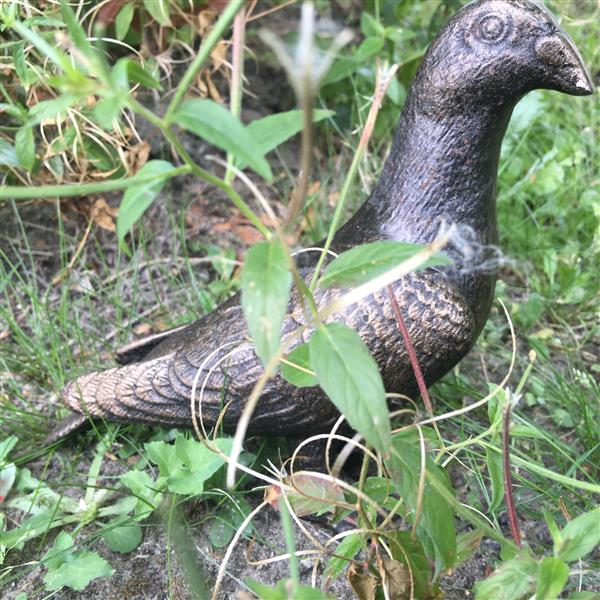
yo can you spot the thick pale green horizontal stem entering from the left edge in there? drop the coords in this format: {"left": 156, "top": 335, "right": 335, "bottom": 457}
{"left": 0, "top": 165, "right": 191, "bottom": 203}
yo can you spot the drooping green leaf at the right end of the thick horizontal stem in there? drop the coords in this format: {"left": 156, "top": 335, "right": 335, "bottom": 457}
{"left": 117, "top": 160, "right": 173, "bottom": 240}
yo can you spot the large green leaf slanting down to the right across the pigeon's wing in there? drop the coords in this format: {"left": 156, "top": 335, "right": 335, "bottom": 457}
{"left": 309, "top": 323, "right": 391, "bottom": 455}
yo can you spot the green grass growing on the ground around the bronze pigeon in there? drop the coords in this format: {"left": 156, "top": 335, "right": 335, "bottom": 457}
{"left": 0, "top": 2, "right": 600, "bottom": 593}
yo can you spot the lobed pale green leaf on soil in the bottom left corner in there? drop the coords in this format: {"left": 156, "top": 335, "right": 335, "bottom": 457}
{"left": 43, "top": 531, "right": 113, "bottom": 592}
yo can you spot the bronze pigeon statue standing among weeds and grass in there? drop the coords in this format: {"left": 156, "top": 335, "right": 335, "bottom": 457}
{"left": 55, "top": 0, "right": 593, "bottom": 437}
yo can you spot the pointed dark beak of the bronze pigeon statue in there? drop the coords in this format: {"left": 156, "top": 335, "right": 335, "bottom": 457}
{"left": 535, "top": 30, "right": 594, "bottom": 96}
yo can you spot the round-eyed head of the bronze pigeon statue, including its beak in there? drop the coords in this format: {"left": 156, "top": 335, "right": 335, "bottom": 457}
{"left": 418, "top": 0, "right": 593, "bottom": 112}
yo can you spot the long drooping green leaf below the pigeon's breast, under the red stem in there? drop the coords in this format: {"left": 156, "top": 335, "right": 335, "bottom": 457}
{"left": 386, "top": 431, "right": 456, "bottom": 568}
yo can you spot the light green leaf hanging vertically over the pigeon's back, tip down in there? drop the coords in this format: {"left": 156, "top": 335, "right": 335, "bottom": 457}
{"left": 242, "top": 239, "right": 292, "bottom": 366}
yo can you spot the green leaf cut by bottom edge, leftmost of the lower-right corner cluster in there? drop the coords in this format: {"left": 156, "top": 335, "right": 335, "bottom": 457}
{"left": 475, "top": 554, "right": 538, "bottom": 600}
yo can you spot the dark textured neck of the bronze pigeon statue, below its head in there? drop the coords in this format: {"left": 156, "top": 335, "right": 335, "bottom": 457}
{"left": 367, "top": 97, "right": 514, "bottom": 254}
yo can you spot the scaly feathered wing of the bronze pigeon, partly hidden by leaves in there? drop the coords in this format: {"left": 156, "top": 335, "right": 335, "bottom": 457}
{"left": 63, "top": 271, "right": 476, "bottom": 433}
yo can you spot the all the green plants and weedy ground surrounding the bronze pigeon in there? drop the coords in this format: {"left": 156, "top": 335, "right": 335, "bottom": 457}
{"left": 0, "top": 1, "right": 600, "bottom": 599}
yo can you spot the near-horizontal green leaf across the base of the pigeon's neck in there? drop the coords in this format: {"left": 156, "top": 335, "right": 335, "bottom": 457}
{"left": 319, "top": 240, "right": 452, "bottom": 288}
